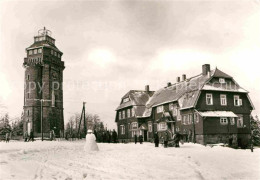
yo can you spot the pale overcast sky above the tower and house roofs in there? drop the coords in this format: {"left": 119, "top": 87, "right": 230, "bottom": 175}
{"left": 0, "top": 0, "right": 260, "bottom": 128}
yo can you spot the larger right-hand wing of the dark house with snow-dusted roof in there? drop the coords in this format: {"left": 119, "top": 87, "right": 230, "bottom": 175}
{"left": 116, "top": 64, "right": 254, "bottom": 147}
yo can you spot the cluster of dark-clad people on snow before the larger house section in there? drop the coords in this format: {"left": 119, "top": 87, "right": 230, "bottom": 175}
{"left": 154, "top": 131, "right": 182, "bottom": 148}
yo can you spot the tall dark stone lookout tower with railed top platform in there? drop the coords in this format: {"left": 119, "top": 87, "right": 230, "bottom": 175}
{"left": 23, "top": 28, "right": 65, "bottom": 137}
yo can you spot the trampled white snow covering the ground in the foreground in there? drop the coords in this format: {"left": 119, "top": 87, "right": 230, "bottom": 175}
{"left": 0, "top": 140, "right": 260, "bottom": 180}
